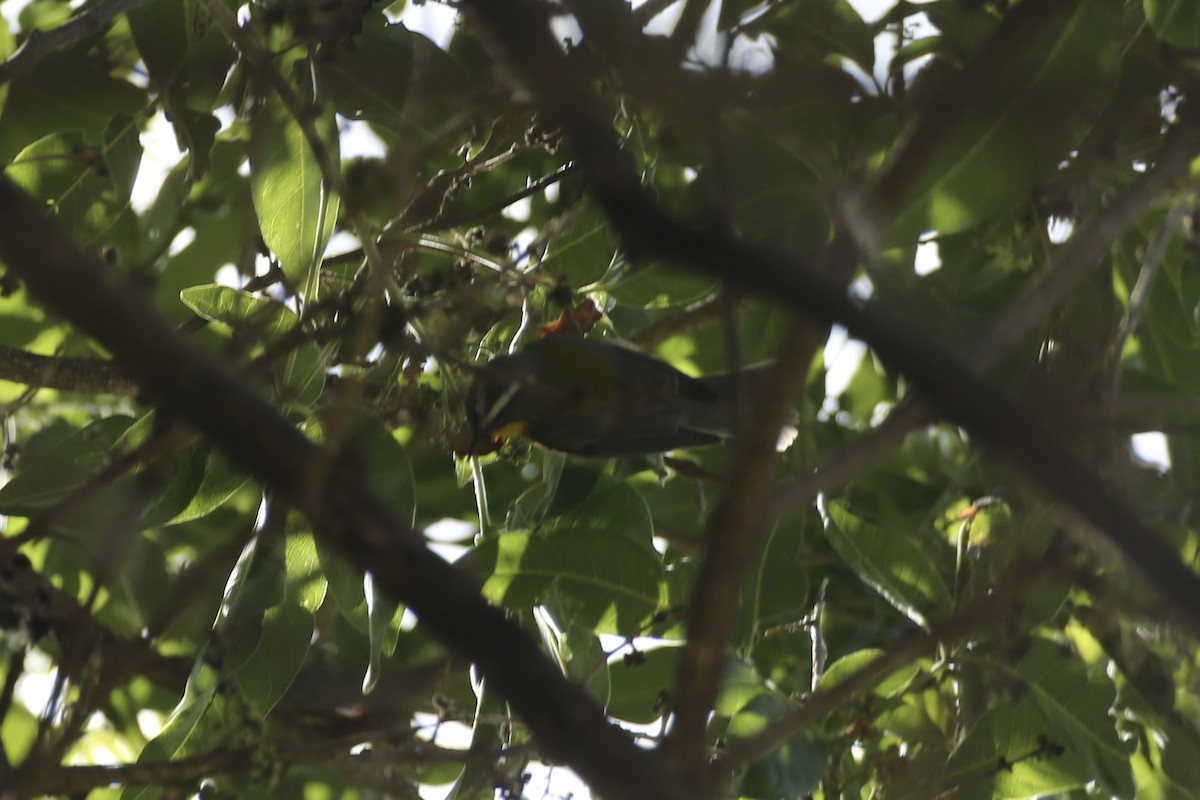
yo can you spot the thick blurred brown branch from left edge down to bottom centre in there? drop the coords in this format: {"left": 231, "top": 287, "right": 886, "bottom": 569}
{"left": 0, "top": 178, "right": 683, "bottom": 800}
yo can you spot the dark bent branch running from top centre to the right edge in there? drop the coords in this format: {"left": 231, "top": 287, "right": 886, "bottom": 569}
{"left": 463, "top": 0, "right": 1200, "bottom": 628}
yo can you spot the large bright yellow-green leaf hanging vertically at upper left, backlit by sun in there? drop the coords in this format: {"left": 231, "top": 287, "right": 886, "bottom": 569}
{"left": 250, "top": 94, "right": 338, "bottom": 284}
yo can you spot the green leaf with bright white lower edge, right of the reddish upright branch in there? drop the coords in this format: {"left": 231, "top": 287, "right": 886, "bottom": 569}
{"left": 821, "top": 500, "right": 950, "bottom": 628}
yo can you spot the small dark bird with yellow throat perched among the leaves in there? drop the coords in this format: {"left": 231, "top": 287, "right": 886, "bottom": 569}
{"left": 467, "top": 335, "right": 796, "bottom": 457}
